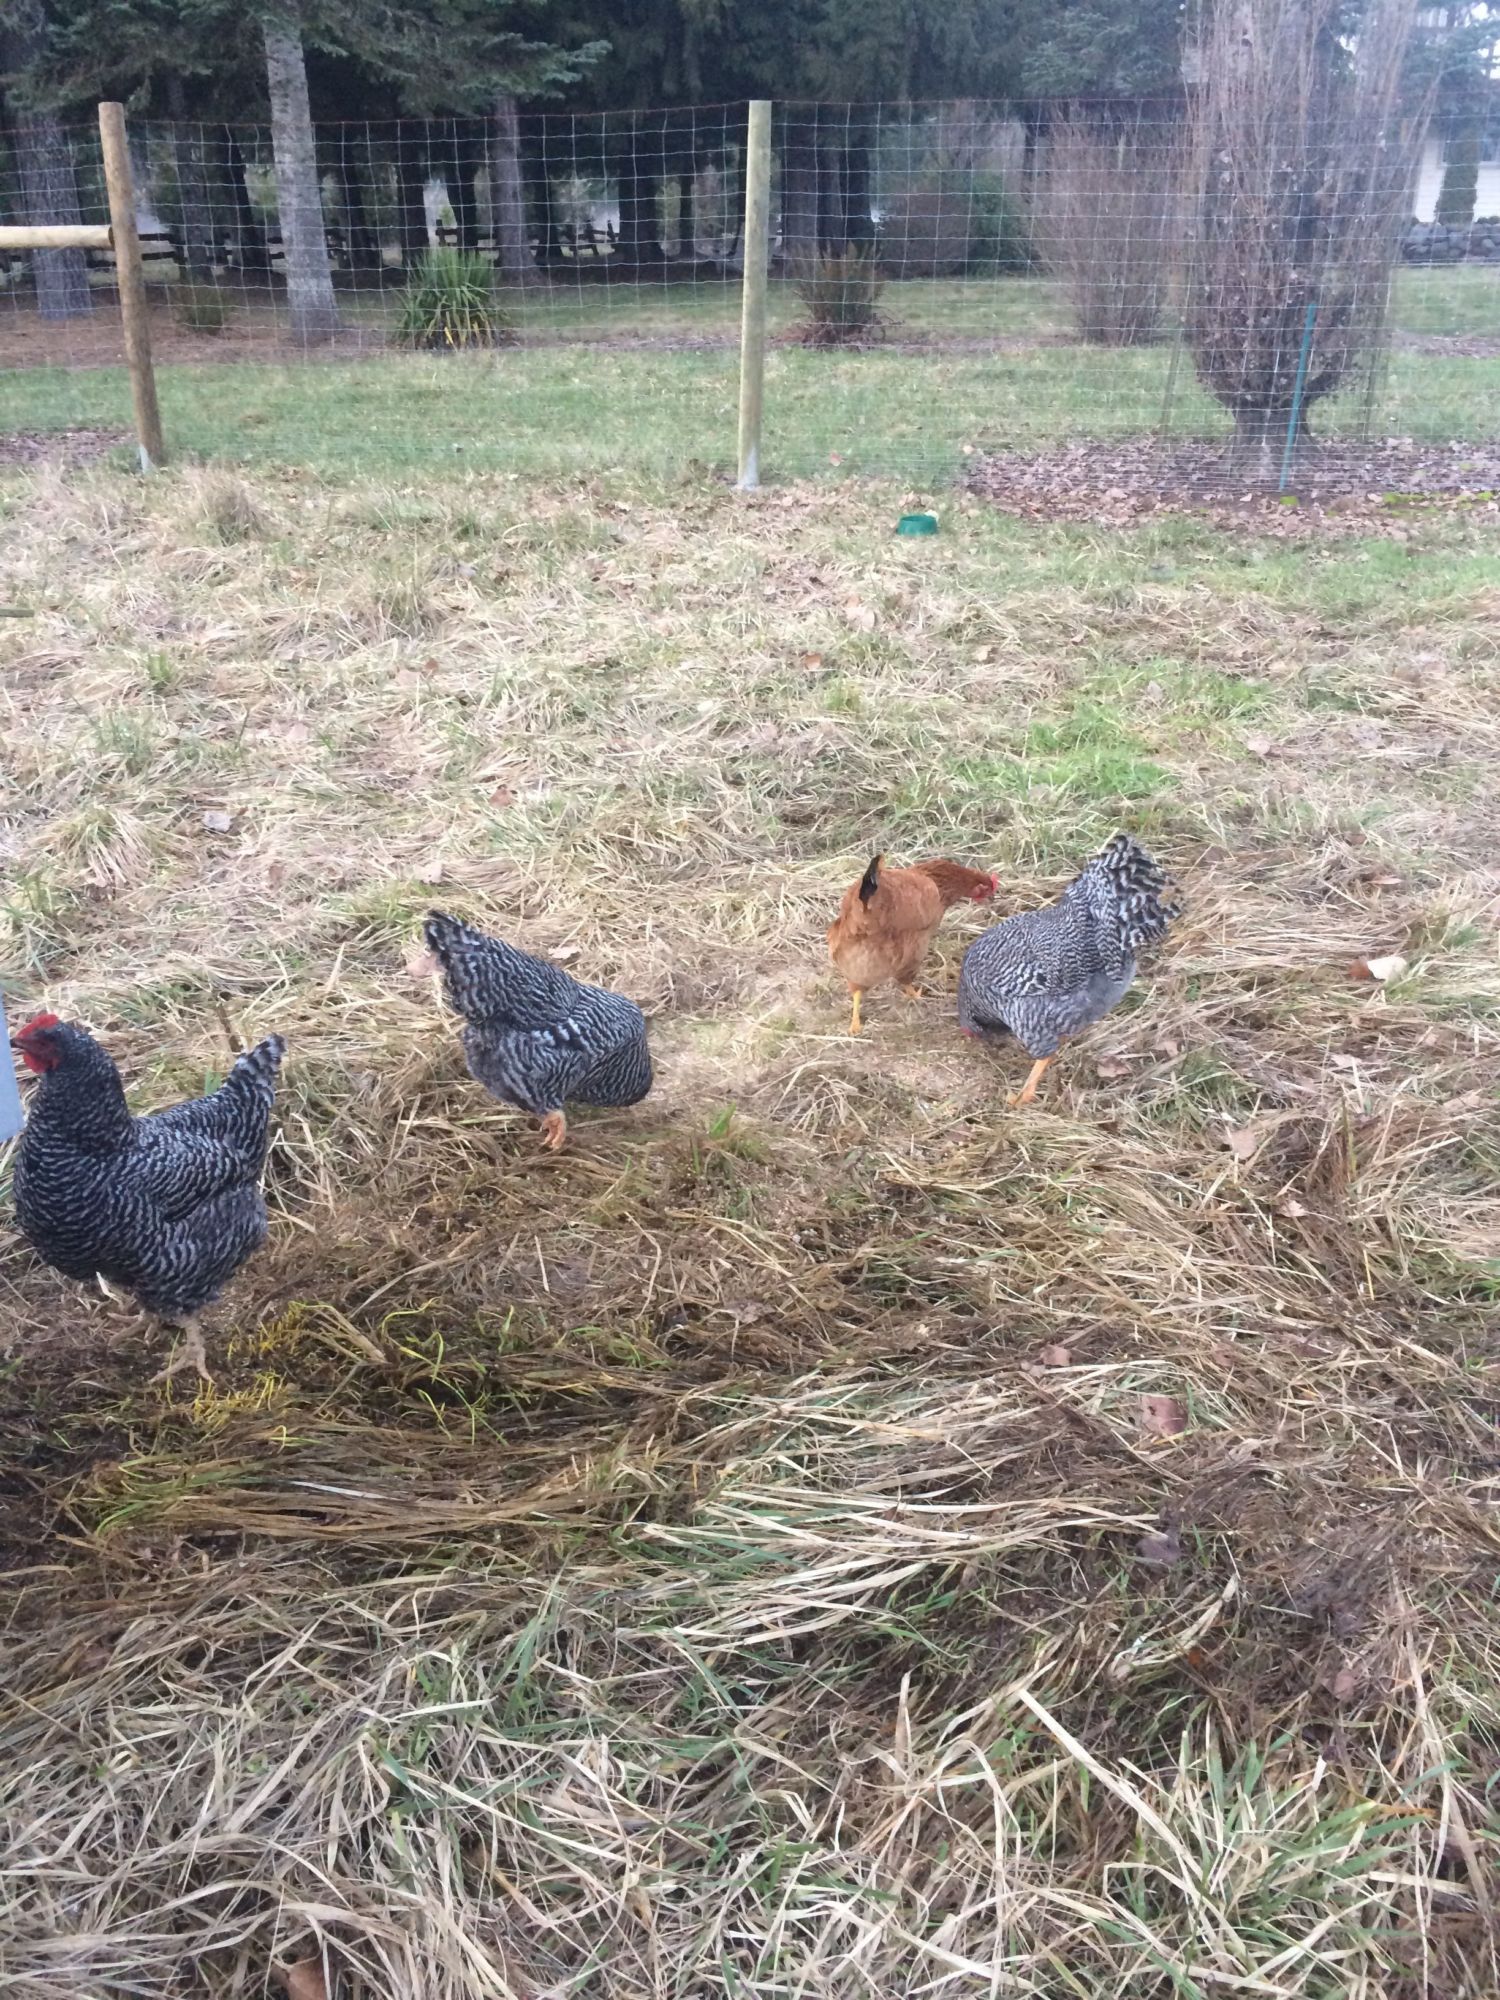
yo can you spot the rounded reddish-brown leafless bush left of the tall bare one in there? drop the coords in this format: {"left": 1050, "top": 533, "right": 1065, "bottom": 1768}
{"left": 1038, "top": 116, "right": 1180, "bottom": 348}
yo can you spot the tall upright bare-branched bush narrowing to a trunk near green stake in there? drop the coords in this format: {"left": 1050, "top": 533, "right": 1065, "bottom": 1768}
{"left": 1186, "top": 0, "right": 1426, "bottom": 482}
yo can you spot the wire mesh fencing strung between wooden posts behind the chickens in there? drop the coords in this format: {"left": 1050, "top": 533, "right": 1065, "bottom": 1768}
{"left": 0, "top": 94, "right": 1500, "bottom": 484}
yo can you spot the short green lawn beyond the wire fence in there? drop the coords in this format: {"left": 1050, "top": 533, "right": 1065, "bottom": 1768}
{"left": 0, "top": 270, "right": 1500, "bottom": 488}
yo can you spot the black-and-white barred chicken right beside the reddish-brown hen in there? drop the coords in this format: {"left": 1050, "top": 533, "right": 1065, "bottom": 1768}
{"left": 958, "top": 834, "right": 1178, "bottom": 1104}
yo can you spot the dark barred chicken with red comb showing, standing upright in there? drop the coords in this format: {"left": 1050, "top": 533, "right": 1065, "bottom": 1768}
{"left": 14, "top": 1014, "right": 286, "bottom": 1382}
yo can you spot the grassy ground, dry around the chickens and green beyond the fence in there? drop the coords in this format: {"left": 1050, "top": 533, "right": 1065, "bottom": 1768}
{"left": 0, "top": 332, "right": 1500, "bottom": 2000}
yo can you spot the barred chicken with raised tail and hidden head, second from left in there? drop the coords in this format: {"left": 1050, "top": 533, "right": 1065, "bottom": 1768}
{"left": 424, "top": 910, "right": 652, "bottom": 1152}
